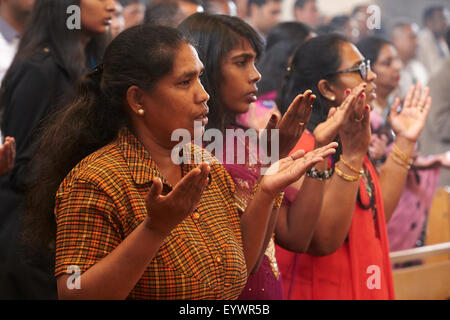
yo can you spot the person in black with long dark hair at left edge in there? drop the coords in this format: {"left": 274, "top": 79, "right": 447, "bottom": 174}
{"left": 0, "top": 0, "right": 115, "bottom": 299}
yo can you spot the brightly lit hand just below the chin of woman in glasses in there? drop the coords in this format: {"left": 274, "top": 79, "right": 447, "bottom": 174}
{"left": 314, "top": 83, "right": 367, "bottom": 146}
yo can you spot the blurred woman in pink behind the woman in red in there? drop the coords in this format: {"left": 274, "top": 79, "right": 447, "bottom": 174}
{"left": 358, "top": 36, "right": 450, "bottom": 258}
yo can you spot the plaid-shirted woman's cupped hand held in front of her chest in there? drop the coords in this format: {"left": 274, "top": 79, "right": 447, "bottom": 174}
{"left": 145, "top": 163, "right": 210, "bottom": 237}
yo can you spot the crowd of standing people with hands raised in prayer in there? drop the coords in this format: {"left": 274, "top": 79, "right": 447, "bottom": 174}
{"left": 0, "top": 0, "right": 450, "bottom": 300}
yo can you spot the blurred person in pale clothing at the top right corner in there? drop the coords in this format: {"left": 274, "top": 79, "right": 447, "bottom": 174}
{"left": 418, "top": 6, "right": 449, "bottom": 76}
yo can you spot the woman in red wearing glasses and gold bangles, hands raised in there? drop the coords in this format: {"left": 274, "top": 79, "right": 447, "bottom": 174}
{"left": 277, "top": 35, "right": 431, "bottom": 299}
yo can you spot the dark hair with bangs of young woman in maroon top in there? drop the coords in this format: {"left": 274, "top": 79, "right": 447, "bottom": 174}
{"left": 178, "top": 13, "right": 263, "bottom": 130}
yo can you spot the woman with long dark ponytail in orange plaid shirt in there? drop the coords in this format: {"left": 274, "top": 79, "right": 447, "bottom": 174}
{"left": 30, "top": 25, "right": 330, "bottom": 299}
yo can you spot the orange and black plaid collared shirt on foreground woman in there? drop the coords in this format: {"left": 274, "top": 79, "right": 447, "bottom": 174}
{"left": 55, "top": 129, "right": 247, "bottom": 299}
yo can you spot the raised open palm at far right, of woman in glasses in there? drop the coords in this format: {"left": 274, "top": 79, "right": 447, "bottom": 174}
{"left": 389, "top": 83, "right": 431, "bottom": 142}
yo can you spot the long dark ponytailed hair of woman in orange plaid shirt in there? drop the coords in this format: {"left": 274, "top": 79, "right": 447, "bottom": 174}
{"left": 24, "top": 25, "right": 187, "bottom": 249}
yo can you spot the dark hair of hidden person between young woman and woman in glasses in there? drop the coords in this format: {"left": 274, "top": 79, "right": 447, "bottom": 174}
{"left": 258, "top": 22, "right": 311, "bottom": 95}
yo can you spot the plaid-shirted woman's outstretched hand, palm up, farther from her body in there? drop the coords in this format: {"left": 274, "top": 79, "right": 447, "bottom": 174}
{"left": 260, "top": 142, "right": 338, "bottom": 197}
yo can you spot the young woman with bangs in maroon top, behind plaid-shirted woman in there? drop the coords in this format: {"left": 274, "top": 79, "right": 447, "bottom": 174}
{"left": 179, "top": 13, "right": 337, "bottom": 299}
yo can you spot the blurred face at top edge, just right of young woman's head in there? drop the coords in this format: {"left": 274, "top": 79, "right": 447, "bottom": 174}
{"left": 248, "top": 0, "right": 281, "bottom": 39}
